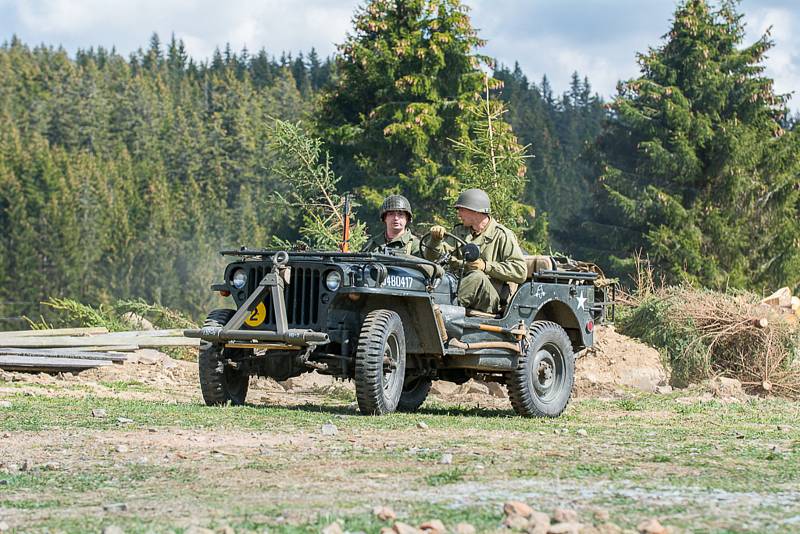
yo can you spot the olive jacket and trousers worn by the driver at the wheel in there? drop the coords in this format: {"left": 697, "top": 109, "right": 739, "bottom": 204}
{"left": 425, "top": 218, "right": 528, "bottom": 313}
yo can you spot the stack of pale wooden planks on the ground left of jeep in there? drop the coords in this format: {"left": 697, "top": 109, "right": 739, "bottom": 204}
{"left": 0, "top": 328, "right": 200, "bottom": 372}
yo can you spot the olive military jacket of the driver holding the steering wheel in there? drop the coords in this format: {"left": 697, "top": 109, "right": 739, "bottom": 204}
{"left": 425, "top": 217, "right": 528, "bottom": 286}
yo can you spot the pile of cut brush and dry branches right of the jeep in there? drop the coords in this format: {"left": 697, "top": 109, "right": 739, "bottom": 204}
{"left": 620, "top": 287, "right": 800, "bottom": 399}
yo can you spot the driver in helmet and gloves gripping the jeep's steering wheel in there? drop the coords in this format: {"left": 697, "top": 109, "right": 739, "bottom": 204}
{"left": 425, "top": 189, "right": 528, "bottom": 313}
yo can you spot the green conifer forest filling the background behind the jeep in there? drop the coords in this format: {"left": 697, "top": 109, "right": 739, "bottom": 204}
{"left": 0, "top": 0, "right": 800, "bottom": 329}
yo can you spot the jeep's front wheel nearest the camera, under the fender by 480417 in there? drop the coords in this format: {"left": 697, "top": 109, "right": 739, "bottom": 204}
{"left": 355, "top": 310, "right": 406, "bottom": 415}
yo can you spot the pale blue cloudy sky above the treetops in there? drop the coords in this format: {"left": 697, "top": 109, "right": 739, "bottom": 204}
{"left": 0, "top": 0, "right": 800, "bottom": 110}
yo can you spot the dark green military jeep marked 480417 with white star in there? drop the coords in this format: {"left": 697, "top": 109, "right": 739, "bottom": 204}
{"left": 185, "top": 236, "right": 613, "bottom": 417}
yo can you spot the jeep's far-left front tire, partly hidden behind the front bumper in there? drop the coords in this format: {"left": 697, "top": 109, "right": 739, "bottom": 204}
{"left": 197, "top": 310, "right": 250, "bottom": 406}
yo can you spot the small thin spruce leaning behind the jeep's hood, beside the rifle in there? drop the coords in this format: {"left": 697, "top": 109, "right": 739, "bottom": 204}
{"left": 270, "top": 120, "right": 367, "bottom": 250}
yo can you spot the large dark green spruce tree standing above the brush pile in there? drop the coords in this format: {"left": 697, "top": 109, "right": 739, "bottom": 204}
{"left": 576, "top": 0, "right": 800, "bottom": 290}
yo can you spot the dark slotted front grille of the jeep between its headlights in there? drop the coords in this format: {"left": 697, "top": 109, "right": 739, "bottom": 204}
{"left": 247, "top": 266, "right": 322, "bottom": 328}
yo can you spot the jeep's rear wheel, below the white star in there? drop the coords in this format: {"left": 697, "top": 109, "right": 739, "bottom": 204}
{"left": 507, "top": 321, "right": 575, "bottom": 417}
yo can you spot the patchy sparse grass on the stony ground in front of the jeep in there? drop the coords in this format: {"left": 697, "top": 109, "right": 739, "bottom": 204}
{"left": 0, "top": 388, "right": 800, "bottom": 532}
